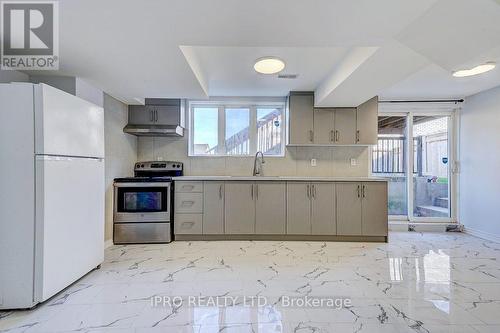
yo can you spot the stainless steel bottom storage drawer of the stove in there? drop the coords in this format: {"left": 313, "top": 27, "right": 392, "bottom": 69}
{"left": 113, "top": 223, "right": 172, "bottom": 244}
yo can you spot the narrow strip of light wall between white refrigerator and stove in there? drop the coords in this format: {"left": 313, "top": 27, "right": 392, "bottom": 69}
{"left": 104, "top": 94, "right": 137, "bottom": 240}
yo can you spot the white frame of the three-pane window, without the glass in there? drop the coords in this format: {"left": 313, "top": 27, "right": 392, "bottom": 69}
{"left": 188, "top": 100, "right": 287, "bottom": 158}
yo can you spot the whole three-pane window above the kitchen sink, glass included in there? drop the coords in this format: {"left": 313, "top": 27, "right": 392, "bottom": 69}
{"left": 189, "top": 102, "right": 285, "bottom": 156}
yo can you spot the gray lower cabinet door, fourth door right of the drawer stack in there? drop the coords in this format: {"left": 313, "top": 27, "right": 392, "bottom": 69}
{"left": 286, "top": 182, "right": 311, "bottom": 235}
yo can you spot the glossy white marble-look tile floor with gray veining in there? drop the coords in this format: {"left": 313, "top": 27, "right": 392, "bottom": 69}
{"left": 0, "top": 232, "right": 500, "bottom": 333}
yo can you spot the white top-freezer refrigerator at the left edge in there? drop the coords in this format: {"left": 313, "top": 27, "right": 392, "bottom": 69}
{"left": 0, "top": 83, "right": 105, "bottom": 309}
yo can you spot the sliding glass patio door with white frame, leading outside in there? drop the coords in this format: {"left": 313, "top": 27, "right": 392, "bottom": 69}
{"left": 371, "top": 112, "right": 455, "bottom": 222}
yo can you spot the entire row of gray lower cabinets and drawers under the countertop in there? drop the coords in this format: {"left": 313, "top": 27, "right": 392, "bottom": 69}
{"left": 174, "top": 180, "right": 388, "bottom": 237}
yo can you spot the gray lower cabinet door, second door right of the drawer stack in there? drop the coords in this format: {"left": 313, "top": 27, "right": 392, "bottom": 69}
{"left": 224, "top": 181, "right": 255, "bottom": 235}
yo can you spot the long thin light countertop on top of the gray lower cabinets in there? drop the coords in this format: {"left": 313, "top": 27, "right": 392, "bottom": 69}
{"left": 173, "top": 176, "right": 388, "bottom": 182}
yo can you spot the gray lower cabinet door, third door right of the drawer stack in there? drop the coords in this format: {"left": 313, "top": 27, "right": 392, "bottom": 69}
{"left": 255, "top": 182, "right": 286, "bottom": 235}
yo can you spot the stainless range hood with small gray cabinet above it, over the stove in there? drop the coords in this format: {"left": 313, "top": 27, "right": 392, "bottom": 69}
{"left": 123, "top": 98, "right": 185, "bottom": 137}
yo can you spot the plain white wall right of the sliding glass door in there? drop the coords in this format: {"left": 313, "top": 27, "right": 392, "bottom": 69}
{"left": 459, "top": 87, "right": 500, "bottom": 241}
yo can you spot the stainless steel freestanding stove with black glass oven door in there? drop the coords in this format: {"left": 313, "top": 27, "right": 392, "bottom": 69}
{"left": 113, "top": 161, "right": 183, "bottom": 244}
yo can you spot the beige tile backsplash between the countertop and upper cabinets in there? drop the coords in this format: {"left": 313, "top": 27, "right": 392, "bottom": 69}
{"left": 137, "top": 134, "right": 370, "bottom": 177}
